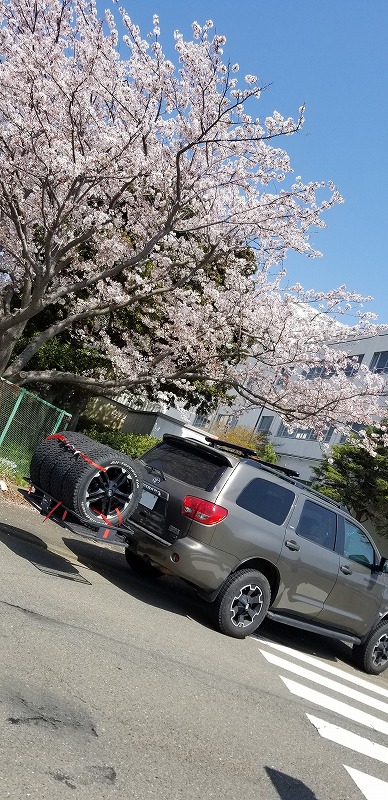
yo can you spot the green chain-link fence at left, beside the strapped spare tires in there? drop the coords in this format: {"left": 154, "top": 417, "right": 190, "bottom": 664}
{"left": 0, "top": 378, "right": 71, "bottom": 476}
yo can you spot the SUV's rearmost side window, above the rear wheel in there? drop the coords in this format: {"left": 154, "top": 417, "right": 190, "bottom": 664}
{"left": 236, "top": 478, "right": 295, "bottom": 525}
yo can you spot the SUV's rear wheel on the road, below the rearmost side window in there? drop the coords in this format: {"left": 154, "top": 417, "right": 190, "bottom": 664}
{"left": 214, "top": 569, "right": 271, "bottom": 639}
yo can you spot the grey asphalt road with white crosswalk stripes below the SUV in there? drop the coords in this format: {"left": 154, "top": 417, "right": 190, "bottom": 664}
{"left": 0, "top": 504, "right": 388, "bottom": 800}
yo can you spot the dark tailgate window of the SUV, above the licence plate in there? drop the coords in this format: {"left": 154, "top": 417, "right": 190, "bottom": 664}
{"left": 141, "top": 442, "right": 226, "bottom": 492}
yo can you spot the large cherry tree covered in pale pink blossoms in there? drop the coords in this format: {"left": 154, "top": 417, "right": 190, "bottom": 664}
{"left": 0, "top": 0, "right": 384, "bottom": 438}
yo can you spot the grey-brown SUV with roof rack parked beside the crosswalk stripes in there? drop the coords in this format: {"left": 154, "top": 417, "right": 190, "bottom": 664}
{"left": 126, "top": 435, "right": 388, "bottom": 674}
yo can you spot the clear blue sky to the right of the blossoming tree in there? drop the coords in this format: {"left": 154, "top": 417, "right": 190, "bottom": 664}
{"left": 104, "top": 0, "right": 388, "bottom": 323}
